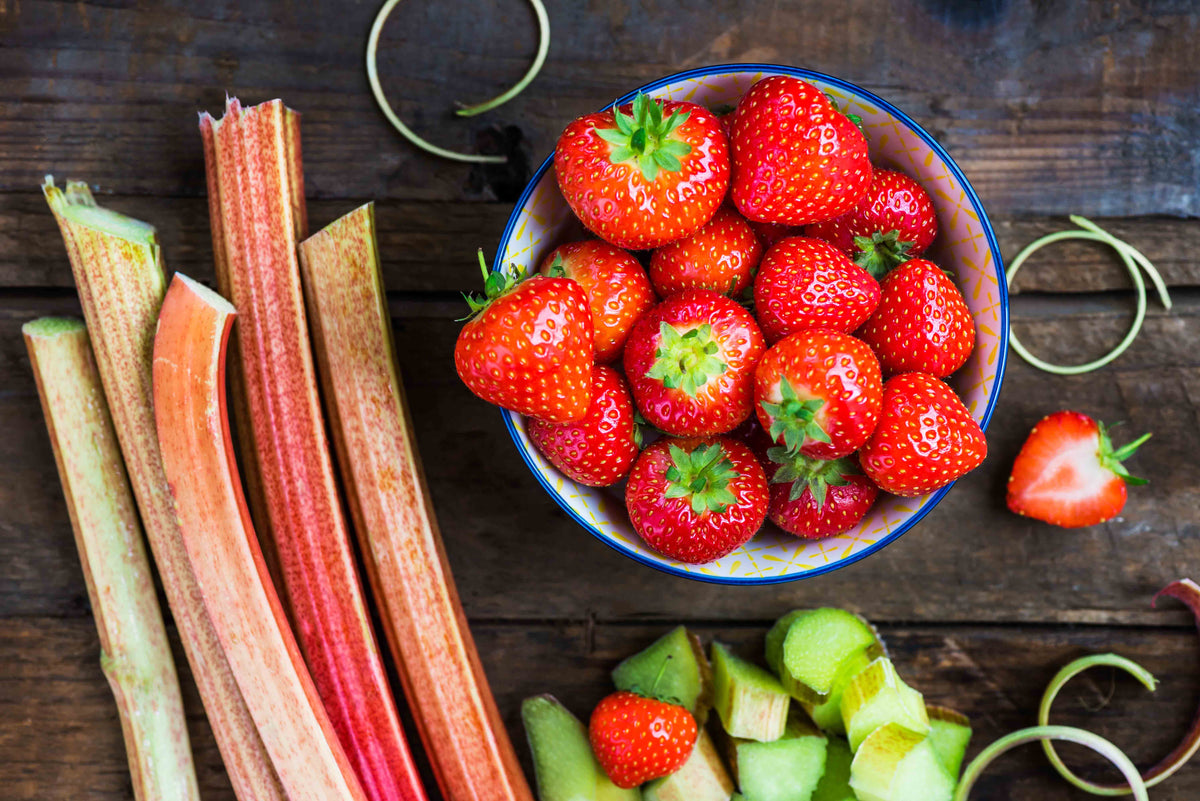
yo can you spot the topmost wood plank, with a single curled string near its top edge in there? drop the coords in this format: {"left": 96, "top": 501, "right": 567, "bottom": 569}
{"left": 0, "top": 0, "right": 1200, "bottom": 216}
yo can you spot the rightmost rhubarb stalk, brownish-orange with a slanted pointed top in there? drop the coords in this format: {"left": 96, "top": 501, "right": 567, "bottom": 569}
{"left": 300, "top": 204, "right": 532, "bottom": 801}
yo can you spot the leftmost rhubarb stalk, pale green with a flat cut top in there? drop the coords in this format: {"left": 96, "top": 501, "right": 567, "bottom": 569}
{"left": 22, "top": 318, "right": 199, "bottom": 801}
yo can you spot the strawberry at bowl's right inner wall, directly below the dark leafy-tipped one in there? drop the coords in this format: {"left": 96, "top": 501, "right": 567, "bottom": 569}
{"left": 858, "top": 259, "right": 974, "bottom": 378}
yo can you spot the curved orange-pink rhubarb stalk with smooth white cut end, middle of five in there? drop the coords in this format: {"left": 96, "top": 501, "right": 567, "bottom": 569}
{"left": 154, "top": 273, "right": 366, "bottom": 801}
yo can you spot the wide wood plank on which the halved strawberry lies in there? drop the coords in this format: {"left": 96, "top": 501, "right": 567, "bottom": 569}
{"left": 0, "top": 294, "right": 1200, "bottom": 624}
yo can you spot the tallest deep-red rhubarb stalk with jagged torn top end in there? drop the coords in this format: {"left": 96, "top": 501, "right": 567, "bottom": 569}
{"left": 200, "top": 100, "right": 425, "bottom": 801}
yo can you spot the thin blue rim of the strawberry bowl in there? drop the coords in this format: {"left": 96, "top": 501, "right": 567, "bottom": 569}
{"left": 492, "top": 64, "right": 1008, "bottom": 585}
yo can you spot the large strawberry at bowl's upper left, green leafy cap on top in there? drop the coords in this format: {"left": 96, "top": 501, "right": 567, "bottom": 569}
{"left": 554, "top": 95, "right": 730, "bottom": 251}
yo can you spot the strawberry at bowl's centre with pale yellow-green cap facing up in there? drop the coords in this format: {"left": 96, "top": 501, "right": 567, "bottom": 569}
{"left": 625, "top": 289, "right": 766, "bottom": 436}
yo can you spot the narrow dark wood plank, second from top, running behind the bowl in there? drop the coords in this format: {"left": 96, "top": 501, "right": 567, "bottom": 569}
{"left": 0, "top": 190, "right": 1200, "bottom": 291}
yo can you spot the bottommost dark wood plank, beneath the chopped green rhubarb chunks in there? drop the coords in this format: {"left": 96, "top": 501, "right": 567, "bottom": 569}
{"left": 0, "top": 618, "right": 1200, "bottom": 801}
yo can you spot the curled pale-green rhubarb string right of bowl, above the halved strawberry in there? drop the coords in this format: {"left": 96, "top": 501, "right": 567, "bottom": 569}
{"left": 1004, "top": 215, "right": 1171, "bottom": 375}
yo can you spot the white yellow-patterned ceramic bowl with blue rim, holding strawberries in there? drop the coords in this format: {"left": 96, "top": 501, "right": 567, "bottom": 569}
{"left": 494, "top": 64, "right": 1008, "bottom": 584}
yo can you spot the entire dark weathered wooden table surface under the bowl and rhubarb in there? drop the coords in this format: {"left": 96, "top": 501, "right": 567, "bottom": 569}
{"left": 0, "top": 0, "right": 1200, "bottom": 801}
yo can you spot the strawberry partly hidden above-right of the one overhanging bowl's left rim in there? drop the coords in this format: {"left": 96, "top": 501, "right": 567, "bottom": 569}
{"left": 540, "top": 239, "right": 658, "bottom": 365}
